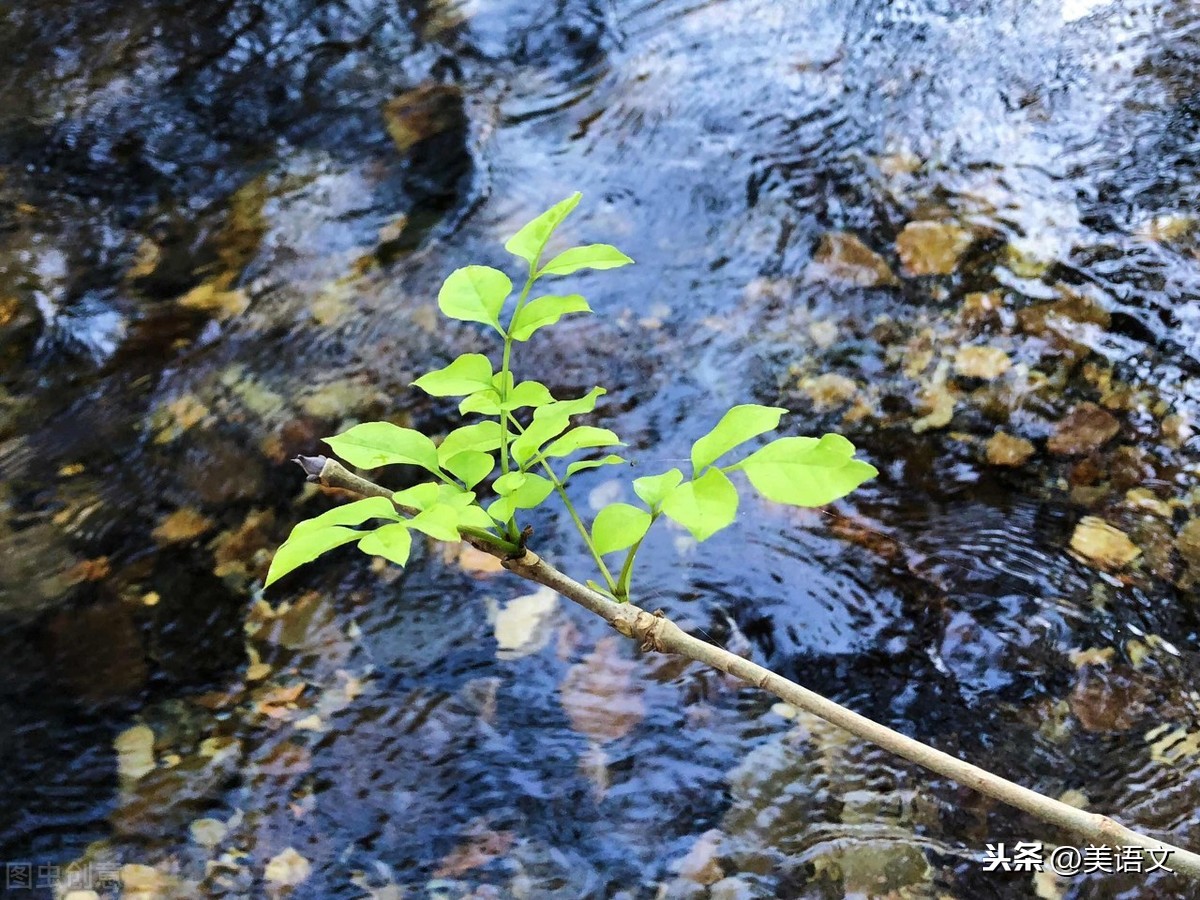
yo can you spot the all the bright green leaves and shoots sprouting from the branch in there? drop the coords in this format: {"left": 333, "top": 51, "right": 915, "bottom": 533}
{"left": 266, "top": 193, "right": 877, "bottom": 600}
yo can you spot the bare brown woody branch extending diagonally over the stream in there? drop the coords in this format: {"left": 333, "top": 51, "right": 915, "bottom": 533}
{"left": 298, "top": 456, "right": 1200, "bottom": 878}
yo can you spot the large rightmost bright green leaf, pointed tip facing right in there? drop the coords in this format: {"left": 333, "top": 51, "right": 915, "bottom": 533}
{"left": 731, "top": 434, "right": 880, "bottom": 506}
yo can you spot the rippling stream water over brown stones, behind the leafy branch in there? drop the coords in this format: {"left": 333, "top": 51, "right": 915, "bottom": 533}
{"left": 0, "top": 0, "right": 1200, "bottom": 900}
